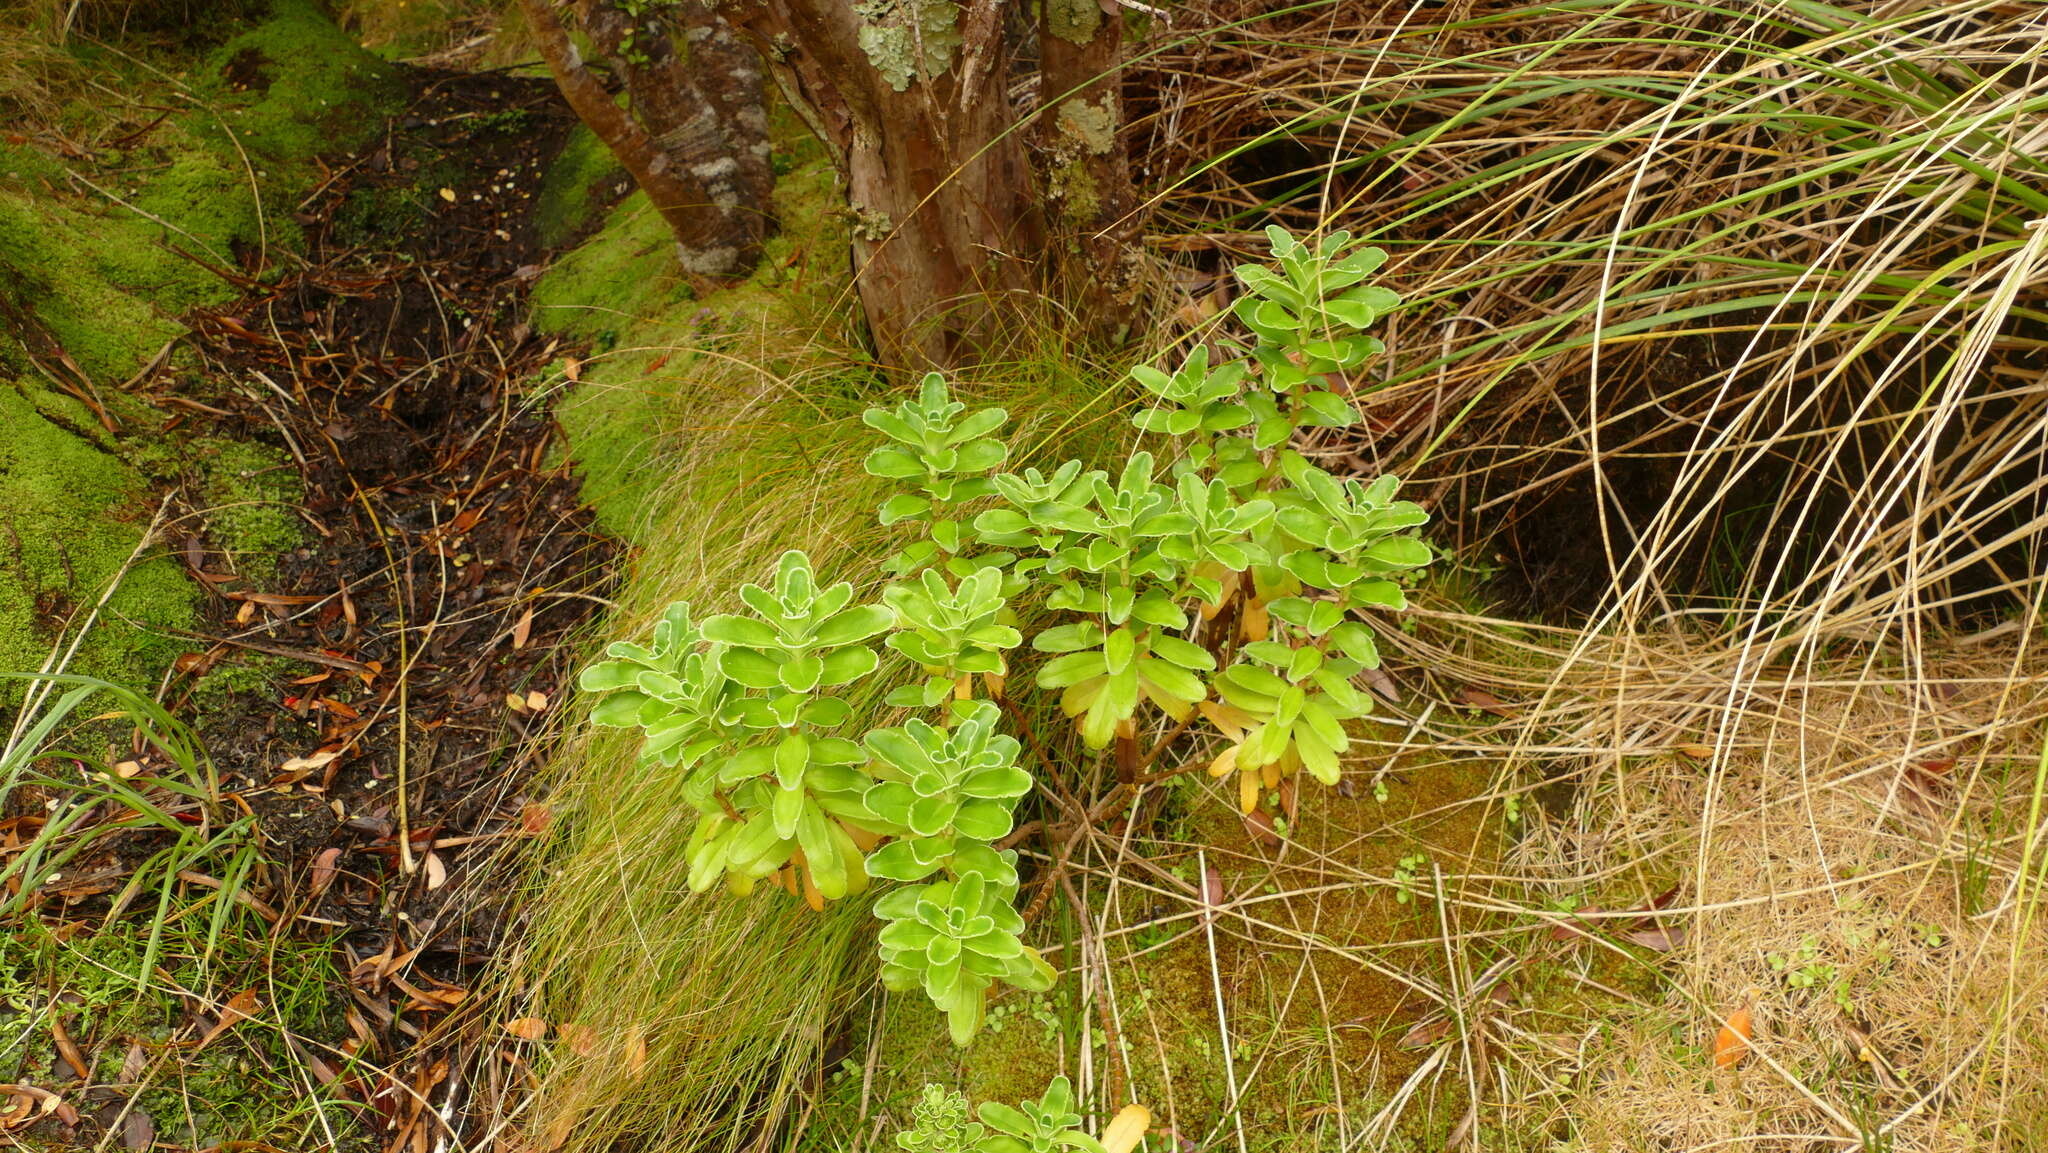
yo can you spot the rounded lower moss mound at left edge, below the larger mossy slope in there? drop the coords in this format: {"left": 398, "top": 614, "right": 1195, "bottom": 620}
{"left": 0, "top": 383, "right": 197, "bottom": 702}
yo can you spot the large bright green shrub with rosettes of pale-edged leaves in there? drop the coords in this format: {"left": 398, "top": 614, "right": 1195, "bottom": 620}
{"left": 582, "top": 229, "right": 1432, "bottom": 1048}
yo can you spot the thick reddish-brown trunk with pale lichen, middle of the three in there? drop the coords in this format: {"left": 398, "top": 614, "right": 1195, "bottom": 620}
{"left": 741, "top": 0, "right": 1044, "bottom": 369}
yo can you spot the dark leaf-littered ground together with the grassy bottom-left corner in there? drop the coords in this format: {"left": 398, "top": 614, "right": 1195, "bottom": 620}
{"left": 0, "top": 27, "right": 616, "bottom": 1149}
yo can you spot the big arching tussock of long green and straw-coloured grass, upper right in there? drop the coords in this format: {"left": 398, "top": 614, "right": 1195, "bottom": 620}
{"left": 1147, "top": 0, "right": 2048, "bottom": 629}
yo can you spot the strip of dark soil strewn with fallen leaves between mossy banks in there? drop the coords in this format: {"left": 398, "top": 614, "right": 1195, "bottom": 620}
{"left": 136, "top": 70, "right": 616, "bottom": 1147}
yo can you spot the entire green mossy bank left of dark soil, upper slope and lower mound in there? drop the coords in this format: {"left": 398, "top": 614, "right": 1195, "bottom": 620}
{"left": 0, "top": 0, "right": 403, "bottom": 702}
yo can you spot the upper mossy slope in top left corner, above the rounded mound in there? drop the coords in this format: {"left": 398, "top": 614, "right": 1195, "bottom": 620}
{"left": 0, "top": 0, "right": 403, "bottom": 383}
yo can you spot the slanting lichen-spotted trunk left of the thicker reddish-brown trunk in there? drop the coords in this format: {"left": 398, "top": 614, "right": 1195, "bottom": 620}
{"left": 520, "top": 0, "right": 774, "bottom": 279}
